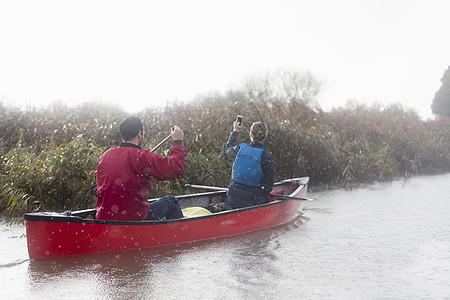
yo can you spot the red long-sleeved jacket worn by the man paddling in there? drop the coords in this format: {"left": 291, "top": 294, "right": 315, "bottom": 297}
{"left": 95, "top": 141, "right": 187, "bottom": 221}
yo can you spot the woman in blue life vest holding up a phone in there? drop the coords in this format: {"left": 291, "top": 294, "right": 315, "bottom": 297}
{"left": 225, "top": 121, "right": 273, "bottom": 208}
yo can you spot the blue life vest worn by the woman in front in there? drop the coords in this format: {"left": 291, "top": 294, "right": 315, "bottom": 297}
{"left": 231, "top": 144, "right": 266, "bottom": 187}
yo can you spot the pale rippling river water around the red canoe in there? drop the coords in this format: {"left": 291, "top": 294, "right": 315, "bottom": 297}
{"left": 0, "top": 174, "right": 450, "bottom": 299}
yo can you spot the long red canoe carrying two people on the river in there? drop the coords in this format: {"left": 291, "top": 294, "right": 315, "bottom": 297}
{"left": 25, "top": 177, "right": 309, "bottom": 259}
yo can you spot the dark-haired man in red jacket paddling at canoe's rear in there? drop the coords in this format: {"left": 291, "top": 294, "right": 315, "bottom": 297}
{"left": 95, "top": 116, "right": 187, "bottom": 221}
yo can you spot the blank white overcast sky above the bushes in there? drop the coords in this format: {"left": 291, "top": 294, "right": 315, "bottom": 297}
{"left": 0, "top": 0, "right": 450, "bottom": 119}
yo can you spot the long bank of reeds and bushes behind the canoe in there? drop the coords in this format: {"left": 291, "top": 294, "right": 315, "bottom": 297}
{"left": 0, "top": 74, "right": 450, "bottom": 217}
